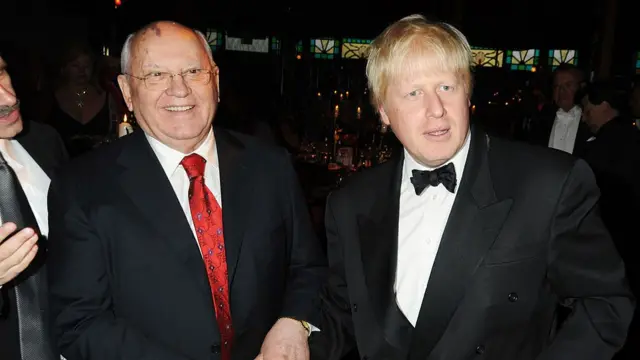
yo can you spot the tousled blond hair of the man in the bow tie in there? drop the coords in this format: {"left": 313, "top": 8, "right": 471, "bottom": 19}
{"left": 366, "top": 15, "right": 473, "bottom": 109}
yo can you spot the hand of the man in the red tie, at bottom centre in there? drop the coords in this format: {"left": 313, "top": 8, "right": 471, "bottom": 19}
{"left": 255, "top": 318, "right": 309, "bottom": 360}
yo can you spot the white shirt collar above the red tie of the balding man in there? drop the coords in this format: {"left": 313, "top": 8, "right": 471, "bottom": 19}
{"left": 145, "top": 129, "right": 218, "bottom": 178}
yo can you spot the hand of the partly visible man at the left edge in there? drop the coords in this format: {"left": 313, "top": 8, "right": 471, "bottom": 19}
{"left": 0, "top": 223, "right": 38, "bottom": 286}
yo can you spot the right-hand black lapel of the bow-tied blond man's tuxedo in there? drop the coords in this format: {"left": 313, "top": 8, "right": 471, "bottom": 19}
{"left": 410, "top": 129, "right": 511, "bottom": 360}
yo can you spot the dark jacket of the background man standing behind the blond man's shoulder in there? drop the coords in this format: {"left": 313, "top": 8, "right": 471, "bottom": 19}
{"left": 515, "top": 105, "right": 592, "bottom": 156}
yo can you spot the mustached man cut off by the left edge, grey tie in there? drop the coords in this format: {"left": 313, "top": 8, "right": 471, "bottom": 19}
{"left": 0, "top": 48, "right": 67, "bottom": 360}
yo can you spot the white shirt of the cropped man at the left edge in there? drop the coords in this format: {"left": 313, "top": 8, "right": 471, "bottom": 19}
{"left": 0, "top": 139, "right": 51, "bottom": 237}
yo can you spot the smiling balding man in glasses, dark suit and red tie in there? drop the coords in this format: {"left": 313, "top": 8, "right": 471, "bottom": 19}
{"left": 49, "top": 22, "right": 326, "bottom": 360}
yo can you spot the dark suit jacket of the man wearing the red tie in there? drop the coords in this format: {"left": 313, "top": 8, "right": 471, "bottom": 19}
{"left": 49, "top": 131, "right": 325, "bottom": 360}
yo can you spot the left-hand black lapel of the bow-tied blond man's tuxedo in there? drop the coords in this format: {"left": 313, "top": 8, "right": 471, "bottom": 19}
{"left": 358, "top": 152, "right": 403, "bottom": 347}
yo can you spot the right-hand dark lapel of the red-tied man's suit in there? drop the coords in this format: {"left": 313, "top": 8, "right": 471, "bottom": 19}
{"left": 215, "top": 129, "right": 249, "bottom": 287}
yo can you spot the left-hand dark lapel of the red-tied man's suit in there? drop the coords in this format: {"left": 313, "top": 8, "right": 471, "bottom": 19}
{"left": 118, "top": 131, "right": 210, "bottom": 296}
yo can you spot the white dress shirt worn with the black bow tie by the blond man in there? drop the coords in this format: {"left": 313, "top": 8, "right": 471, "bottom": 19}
{"left": 394, "top": 134, "right": 471, "bottom": 326}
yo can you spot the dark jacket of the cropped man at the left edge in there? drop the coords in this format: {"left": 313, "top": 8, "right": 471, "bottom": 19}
{"left": 0, "top": 122, "right": 67, "bottom": 360}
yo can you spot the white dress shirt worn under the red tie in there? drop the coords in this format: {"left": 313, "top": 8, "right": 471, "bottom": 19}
{"left": 145, "top": 130, "right": 222, "bottom": 242}
